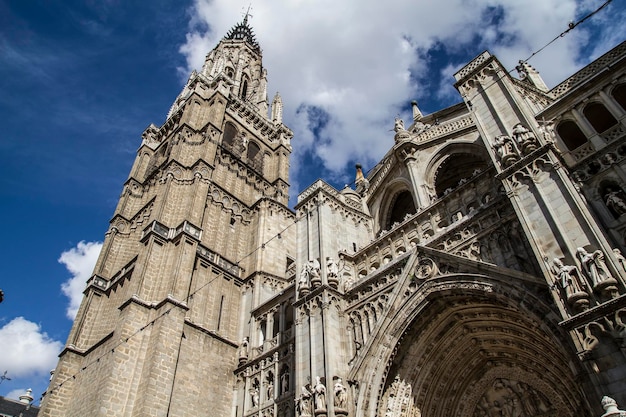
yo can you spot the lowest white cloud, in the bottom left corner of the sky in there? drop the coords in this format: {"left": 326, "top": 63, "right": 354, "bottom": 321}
{"left": 0, "top": 317, "right": 63, "bottom": 380}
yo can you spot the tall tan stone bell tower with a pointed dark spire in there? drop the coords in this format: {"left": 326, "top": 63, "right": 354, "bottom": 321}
{"left": 40, "top": 15, "right": 295, "bottom": 417}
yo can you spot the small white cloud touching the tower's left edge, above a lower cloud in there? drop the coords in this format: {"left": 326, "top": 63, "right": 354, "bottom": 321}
{"left": 59, "top": 242, "right": 102, "bottom": 320}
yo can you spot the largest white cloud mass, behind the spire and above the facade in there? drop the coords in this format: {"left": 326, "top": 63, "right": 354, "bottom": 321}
{"left": 180, "top": 0, "right": 615, "bottom": 182}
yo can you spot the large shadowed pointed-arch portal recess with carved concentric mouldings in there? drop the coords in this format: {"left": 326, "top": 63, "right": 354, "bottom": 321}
{"left": 353, "top": 274, "right": 590, "bottom": 417}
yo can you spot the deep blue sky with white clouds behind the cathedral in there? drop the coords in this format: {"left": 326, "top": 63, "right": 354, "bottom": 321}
{"left": 0, "top": 0, "right": 626, "bottom": 401}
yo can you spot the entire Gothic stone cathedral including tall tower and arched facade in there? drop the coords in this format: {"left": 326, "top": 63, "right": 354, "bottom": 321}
{"left": 39, "top": 17, "right": 626, "bottom": 417}
